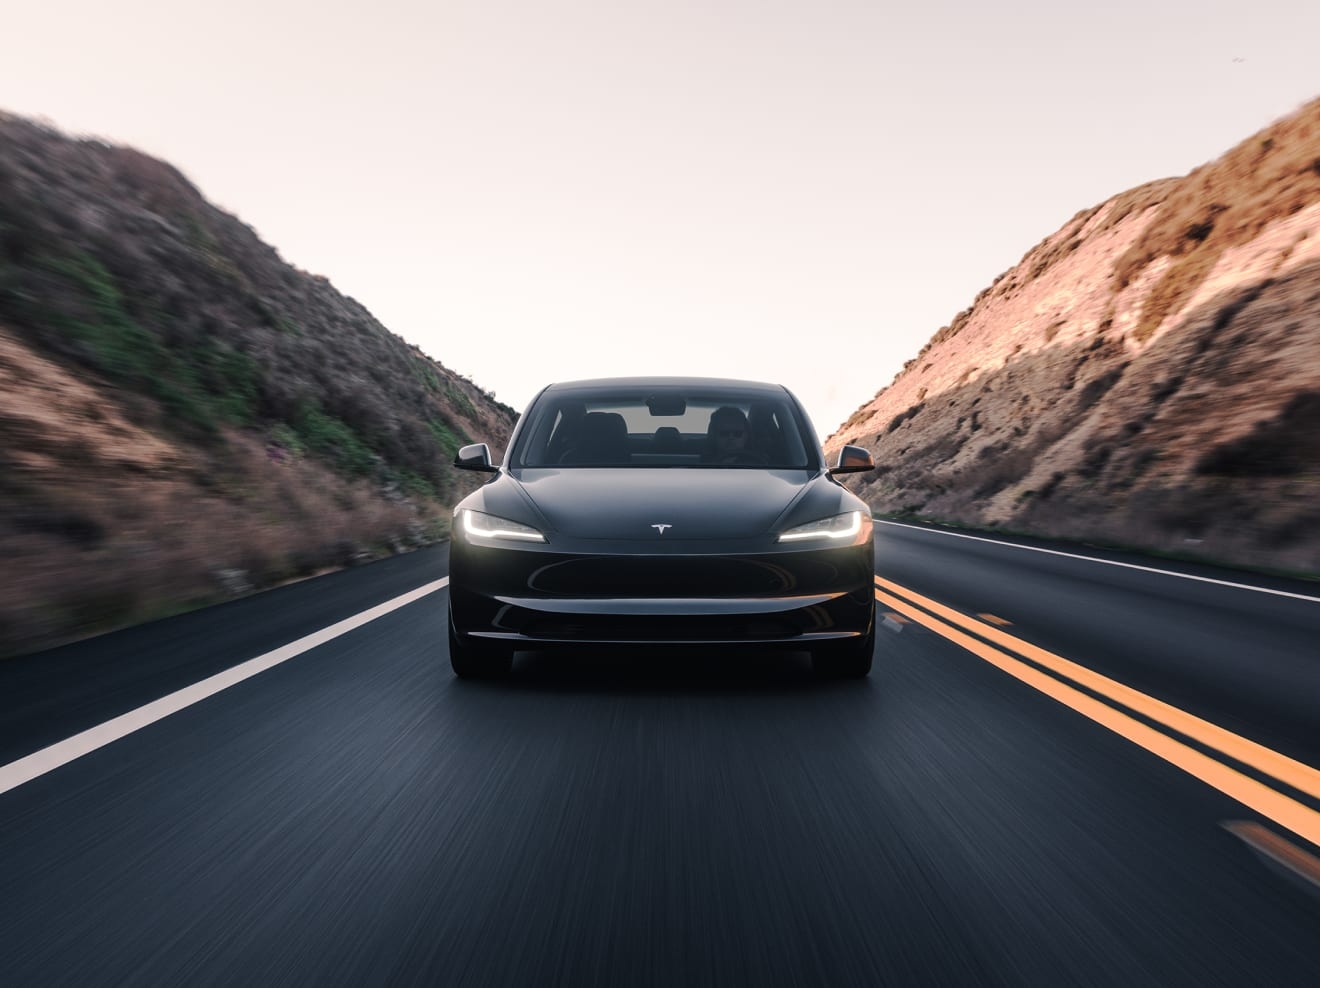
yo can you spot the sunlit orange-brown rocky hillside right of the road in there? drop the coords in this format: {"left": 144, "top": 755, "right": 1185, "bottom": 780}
{"left": 826, "top": 100, "right": 1320, "bottom": 573}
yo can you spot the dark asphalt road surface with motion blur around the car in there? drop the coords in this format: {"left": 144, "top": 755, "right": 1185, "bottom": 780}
{"left": 0, "top": 526, "right": 1320, "bottom": 985}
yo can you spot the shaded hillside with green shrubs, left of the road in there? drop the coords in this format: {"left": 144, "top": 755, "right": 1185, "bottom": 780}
{"left": 0, "top": 115, "right": 516, "bottom": 655}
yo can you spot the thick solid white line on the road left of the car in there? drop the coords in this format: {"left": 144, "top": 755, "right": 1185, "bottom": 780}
{"left": 0, "top": 576, "right": 449, "bottom": 794}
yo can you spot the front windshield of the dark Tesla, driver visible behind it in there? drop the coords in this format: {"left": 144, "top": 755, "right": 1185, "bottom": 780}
{"left": 511, "top": 388, "right": 818, "bottom": 469}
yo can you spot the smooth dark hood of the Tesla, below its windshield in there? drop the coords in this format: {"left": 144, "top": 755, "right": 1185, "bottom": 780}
{"left": 517, "top": 468, "right": 820, "bottom": 540}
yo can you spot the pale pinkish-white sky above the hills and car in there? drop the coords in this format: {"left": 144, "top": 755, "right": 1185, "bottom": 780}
{"left": 0, "top": 0, "right": 1320, "bottom": 439}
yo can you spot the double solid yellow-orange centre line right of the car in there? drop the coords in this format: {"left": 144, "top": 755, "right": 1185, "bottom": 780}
{"left": 875, "top": 577, "right": 1320, "bottom": 861}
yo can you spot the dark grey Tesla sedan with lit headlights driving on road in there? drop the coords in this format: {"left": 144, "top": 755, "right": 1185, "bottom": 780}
{"left": 449, "top": 378, "right": 875, "bottom": 678}
